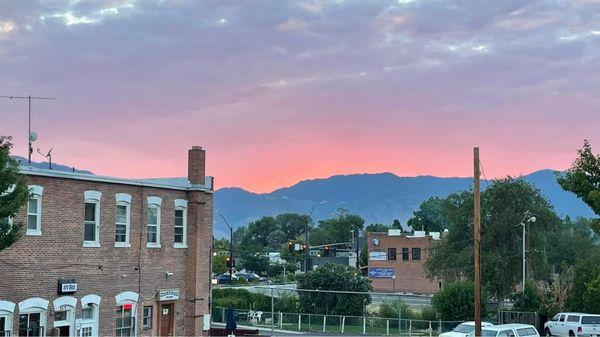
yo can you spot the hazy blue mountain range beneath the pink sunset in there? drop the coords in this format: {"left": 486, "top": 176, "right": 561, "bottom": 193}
{"left": 214, "top": 170, "right": 594, "bottom": 237}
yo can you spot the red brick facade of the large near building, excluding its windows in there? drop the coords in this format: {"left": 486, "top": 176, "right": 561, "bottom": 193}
{"left": 0, "top": 147, "right": 213, "bottom": 336}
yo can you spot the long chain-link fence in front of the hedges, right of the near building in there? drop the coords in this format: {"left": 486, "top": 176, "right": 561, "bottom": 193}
{"left": 212, "top": 286, "right": 462, "bottom": 336}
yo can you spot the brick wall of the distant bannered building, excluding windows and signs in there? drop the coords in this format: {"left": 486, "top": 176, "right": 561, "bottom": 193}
{"left": 367, "top": 233, "right": 439, "bottom": 294}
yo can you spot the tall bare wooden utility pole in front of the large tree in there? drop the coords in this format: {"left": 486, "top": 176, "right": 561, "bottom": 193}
{"left": 473, "top": 147, "right": 481, "bottom": 337}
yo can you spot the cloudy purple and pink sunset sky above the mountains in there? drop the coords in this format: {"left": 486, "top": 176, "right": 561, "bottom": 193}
{"left": 0, "top": 0, "right": 600, "bottom": 192}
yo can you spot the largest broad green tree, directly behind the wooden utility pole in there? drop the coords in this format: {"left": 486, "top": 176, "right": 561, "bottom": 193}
{"left": 425, "top": 177, "right": 560, "bottom": 303}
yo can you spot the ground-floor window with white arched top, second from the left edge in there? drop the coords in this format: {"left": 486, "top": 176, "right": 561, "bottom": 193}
{"left": 19, "top": 297, "right": 48, "bottom": 337}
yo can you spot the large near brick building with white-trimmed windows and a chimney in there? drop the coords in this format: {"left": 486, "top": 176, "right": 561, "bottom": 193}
{"left": 0, "top": 146, "right": 213, "bottom": 337}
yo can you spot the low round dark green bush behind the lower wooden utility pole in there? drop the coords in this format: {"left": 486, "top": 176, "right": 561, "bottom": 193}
{"left": 431, "top": 281, "right": 488, "bottom": 321}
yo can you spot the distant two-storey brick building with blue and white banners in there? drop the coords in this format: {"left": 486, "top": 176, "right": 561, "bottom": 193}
{"left": 367, "top": 229, "right": 441, "bottom": 294}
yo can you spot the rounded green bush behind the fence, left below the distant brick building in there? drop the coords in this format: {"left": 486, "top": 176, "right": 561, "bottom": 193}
{"left": 298, "top": 264, "right": 373, "bottom": 316}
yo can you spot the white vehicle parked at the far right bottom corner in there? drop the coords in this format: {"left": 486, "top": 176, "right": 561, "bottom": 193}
{"left": 544, "top": 312, "right": 600, "bottom": 337}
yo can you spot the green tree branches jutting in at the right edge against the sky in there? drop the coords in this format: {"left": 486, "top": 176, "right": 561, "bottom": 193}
{"left": 557, "top": 140, "right": 600, "bottom": 235}
